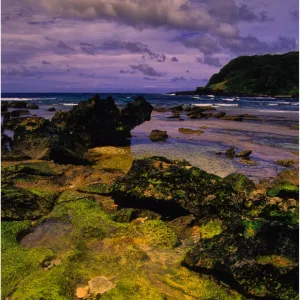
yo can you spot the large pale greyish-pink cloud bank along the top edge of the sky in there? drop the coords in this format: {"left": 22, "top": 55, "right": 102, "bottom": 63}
{"left": 34, "top": 0, "right": 214, "bottom": 30}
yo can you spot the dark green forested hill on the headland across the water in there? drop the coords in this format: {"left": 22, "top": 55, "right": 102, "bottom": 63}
{"left": 205, "top": 52, "right": 299, "bottom": 95}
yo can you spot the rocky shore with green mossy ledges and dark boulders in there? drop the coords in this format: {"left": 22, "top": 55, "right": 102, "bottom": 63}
{"left": 1, "top": 96, "right": 299, "bottom": 300}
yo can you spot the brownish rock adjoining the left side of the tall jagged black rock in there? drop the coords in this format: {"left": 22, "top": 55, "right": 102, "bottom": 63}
{"left": 12, "top": 117, "right": 89, "bottom": 164}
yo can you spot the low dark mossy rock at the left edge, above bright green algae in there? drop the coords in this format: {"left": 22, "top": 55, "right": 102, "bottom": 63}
{"left": 1, "top": 184, "right": 57, "bottom": 220}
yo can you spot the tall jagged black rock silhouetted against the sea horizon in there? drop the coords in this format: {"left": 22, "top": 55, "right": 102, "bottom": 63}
{"left": 52, "top": 95, "right": 153, "bottom": 147}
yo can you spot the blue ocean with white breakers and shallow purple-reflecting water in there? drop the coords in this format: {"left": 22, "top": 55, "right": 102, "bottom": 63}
{"left": 1, "top": 93, "right": 299, "bottom": 182}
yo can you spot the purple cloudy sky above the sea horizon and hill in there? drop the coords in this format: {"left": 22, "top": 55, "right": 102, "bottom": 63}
{"left": 1, "top": 0, "right": 299, "bottom": 93}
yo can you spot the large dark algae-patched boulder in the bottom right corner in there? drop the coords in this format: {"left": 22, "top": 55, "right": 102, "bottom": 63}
{"left": 183, "top": 219, "right": 298, "bottom": 299}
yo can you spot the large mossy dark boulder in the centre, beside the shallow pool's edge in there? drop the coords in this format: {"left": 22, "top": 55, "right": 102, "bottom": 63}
{"left": 112, "top": 157, "right": 240, "bottom": 217}
